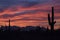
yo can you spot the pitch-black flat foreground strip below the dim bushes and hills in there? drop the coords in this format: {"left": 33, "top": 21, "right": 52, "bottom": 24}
{"left": 0, "top": 32, "right": 60, "bottom": 40}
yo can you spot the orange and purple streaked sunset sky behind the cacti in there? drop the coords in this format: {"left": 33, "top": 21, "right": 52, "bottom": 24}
{"left": 0, "top": 0, "right": 60, "bottom": 28}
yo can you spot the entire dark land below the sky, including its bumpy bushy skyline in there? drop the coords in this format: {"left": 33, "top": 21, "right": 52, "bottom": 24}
{"left": 0, "top": 26, "right": 60, "bottom": 40}
